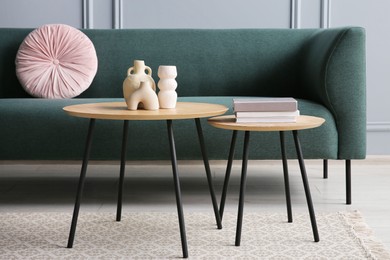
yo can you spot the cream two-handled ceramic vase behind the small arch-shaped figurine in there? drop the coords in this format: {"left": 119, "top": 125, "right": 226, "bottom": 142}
{"left": 123, "top": 60, "right": 156, "bottom": 108}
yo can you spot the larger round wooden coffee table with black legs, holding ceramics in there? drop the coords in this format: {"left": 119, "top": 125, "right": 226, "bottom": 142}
{"left": 63, "top": 102, "right": 228, "bottom": 258}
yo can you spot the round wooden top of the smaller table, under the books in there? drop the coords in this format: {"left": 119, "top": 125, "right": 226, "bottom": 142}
{"left": 208, "top": 115, "right": 325, "bottom": 131}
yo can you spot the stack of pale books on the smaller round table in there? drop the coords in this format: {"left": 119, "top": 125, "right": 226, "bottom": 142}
{"left": 233, "top": 98, "right": 299, "bottom": 123}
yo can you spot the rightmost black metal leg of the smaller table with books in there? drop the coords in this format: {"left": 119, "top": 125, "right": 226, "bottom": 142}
{"left": 293, "top": 130, "right": 320, "bottom": 242}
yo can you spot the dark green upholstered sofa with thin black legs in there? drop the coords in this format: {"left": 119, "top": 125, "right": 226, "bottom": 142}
{"left": 0, "top": 27, "right": 366, "bottom": 203}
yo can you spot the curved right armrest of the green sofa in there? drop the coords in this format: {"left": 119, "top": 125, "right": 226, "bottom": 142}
{"left": 300, "top": 27, "right": 366, "bottom": 159}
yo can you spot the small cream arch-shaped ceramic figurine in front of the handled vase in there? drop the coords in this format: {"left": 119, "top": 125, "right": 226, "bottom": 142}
{"left": 127, "top": 81, "right": 159, "bottom": 110}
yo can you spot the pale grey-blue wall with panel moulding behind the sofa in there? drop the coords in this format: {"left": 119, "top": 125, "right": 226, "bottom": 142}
{"left": 0, "top": 0, "right": 390, "bottom": 155}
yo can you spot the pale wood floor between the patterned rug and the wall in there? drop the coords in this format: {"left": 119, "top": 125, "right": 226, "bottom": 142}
{"left": 0, "top": 156, "right": 390, "bottom": 248}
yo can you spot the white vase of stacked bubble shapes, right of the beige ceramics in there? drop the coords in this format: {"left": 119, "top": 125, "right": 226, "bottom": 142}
{"left": 157, "top": 65, "right": 177, "bottom": 108}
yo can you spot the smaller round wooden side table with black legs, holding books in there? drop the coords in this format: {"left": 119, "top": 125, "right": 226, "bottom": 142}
{"left": 208, "top": 115, "right": 325, "bottom": 246}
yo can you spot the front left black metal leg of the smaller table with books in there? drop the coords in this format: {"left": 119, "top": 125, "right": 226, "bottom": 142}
{"left": 235, "top": 131, "right": 250, "bottom": 246}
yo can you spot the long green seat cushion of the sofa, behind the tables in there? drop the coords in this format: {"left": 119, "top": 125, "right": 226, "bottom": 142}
{"left": 0, "top": 97, "right": 338, "bottom": 160}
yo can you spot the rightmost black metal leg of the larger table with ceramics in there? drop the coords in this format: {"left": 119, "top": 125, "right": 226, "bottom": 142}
{"left": 195, "top": 118, "right": 222, "bottom": 229}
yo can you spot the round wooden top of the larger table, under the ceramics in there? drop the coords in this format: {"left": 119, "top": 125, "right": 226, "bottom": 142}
{"left": 63, "top": 102, "right": 228, "bottom": 120}
